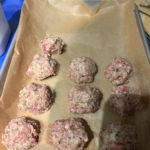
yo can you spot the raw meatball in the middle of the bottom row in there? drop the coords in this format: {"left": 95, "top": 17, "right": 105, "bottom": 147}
{"left": 50, "top": 118, "right": 88, "bottom": 150}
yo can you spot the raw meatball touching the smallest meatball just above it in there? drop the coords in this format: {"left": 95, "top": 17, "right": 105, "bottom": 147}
{"left": 26, "top": 54, "right": 57, "bottom": 80}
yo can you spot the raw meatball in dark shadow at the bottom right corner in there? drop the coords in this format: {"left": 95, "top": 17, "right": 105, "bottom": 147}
{"left": 102, "top": 122, "right": 136, "bottom": 150}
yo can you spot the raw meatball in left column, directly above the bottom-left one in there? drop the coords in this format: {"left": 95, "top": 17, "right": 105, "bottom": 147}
{"left": 18, "top": 83, "right": 52, "bottom": 115}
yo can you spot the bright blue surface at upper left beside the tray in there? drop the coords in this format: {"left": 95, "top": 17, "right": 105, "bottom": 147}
{"left": 0, "top": 0, "right": 24, "bottom": 69}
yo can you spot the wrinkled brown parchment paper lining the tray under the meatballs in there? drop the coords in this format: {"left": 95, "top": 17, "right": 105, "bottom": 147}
{"left": 0, "top": 0, "right": 150, "bottom": 150}
